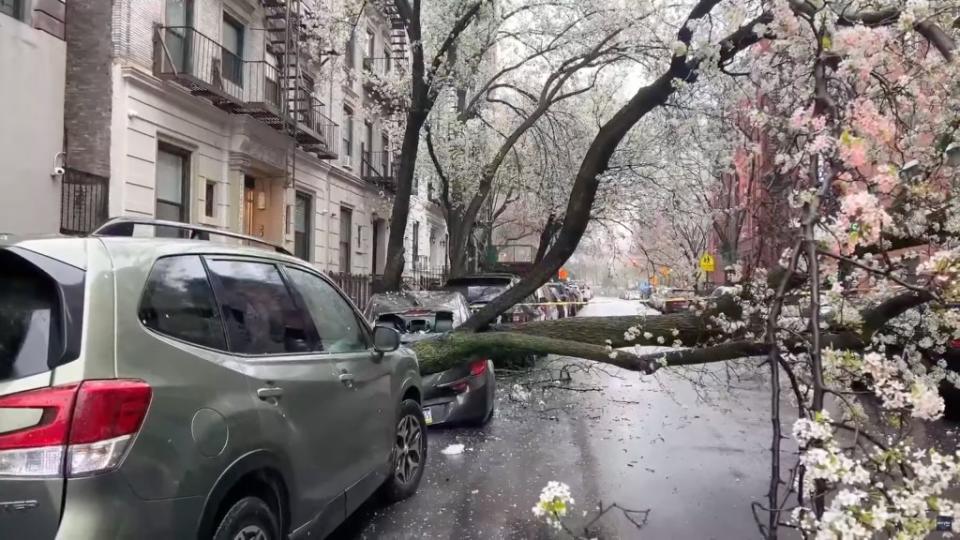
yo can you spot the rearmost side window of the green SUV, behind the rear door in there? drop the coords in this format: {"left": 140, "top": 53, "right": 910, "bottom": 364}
{"left": 139, "top": 255, "right": 227, "bottom": 350}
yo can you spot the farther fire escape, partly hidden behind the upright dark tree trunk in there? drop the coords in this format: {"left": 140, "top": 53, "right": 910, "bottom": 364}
{"left": 360, "top": 0, "right": 408, "bottom": 192}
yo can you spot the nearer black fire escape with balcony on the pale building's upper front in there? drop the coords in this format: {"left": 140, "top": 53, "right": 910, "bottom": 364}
{"left": 154, "top": 0, "right": 338, "bottom": 185}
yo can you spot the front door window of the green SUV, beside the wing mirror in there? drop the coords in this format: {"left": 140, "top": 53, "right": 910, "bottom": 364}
{"left": 287, "top": 267, "right": 369, "bottom": 353}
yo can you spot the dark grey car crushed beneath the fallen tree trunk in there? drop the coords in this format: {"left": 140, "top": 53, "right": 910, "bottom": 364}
{"left": 364, "top": 291, "right": 497, "bottom": 425}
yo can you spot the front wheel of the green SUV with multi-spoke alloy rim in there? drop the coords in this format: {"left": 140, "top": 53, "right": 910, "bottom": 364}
{"left": 382, "top": 399, "right": 427, "bottom": 503}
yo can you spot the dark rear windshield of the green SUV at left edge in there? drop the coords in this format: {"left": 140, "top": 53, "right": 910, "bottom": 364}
{"left": 0, "top": 249, "right": 71, "bottom": 381}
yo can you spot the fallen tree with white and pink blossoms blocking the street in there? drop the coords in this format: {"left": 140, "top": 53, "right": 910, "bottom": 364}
{"left": 394, "top": 0, "right": 960, "bottom": 538}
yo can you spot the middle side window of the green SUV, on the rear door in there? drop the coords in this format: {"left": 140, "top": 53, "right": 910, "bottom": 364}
{"left": 207, "top": 259, "right": 313, "bottom": 354}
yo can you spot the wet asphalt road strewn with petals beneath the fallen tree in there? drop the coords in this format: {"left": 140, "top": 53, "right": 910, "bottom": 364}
{"left": 333, "top": 299, "right": 789, "bottom": 540}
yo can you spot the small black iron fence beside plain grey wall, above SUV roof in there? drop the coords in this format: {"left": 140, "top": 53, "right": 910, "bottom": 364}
{"left": 60, "top": 168, "right": 110, "bottom": 234}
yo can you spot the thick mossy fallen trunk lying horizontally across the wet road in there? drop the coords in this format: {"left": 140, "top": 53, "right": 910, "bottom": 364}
{"left": 410, "top": 286, "right": 933, "bottom": 374}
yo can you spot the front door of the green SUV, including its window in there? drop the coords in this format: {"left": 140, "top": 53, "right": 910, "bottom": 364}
{"left": 285, "top": 266, "right": 395, "bottom": 488}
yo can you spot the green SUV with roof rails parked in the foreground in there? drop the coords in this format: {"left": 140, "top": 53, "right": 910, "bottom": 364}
{"left": 0, "top": 220, "right": 426, "bottom": 540}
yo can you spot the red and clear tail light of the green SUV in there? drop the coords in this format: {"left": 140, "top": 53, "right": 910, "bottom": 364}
{"left": 0, "top": 380, "right": 151, "bottom": 477}
